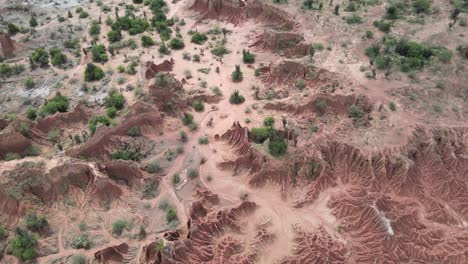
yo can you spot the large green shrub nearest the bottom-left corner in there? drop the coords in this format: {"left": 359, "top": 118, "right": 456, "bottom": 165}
{"left": 7, "top": 227, "right": 37, "bottom": 261}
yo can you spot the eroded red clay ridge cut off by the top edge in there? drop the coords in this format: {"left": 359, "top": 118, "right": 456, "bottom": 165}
{"left": 191, "top": 0, "right": 295, "bottom": 29}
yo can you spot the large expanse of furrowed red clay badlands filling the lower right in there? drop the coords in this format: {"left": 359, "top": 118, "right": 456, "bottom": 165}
{"left": 268, "top": 128, "right": 468, "bottom": 264}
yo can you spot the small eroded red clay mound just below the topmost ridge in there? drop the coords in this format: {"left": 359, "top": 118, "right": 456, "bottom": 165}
{"left": 250, "top": 29, "right": 313, "bottom": 58}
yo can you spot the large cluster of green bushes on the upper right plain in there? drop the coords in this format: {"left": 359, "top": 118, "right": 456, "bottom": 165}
{"left": 365, "top": 35, "right": 452, "bottom": 72}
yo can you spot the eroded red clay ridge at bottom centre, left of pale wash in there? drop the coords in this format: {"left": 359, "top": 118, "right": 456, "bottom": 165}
{"left": 153, "top": 201, "right": 256, "bottom": 264}
